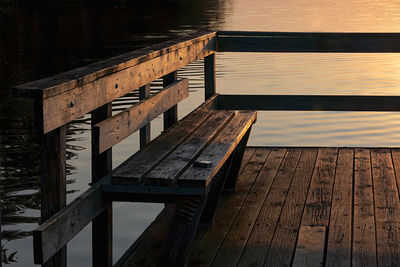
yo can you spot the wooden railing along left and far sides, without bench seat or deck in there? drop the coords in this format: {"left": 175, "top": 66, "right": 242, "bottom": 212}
{"left": 13, "top": 31, "right": 400, "bottom": 266}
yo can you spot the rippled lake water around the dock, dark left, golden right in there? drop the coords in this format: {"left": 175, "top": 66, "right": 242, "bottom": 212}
{"left": 0, "top": 0, "right": 400, "bottom": 266}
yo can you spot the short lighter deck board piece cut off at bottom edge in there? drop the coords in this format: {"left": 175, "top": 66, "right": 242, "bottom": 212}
{"left": 292, "top": 226, "right": 326, "bottom": 267}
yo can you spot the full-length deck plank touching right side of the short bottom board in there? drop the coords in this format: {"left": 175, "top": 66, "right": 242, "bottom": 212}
{"left": 325, "top": 148, "right": 354, "bottom": 266}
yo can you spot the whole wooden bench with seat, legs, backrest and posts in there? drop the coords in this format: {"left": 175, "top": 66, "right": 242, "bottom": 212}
{"left": 13, "top": 32, "right": 256, "bottom": 266}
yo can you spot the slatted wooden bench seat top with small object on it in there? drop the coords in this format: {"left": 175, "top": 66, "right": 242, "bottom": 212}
{"left": 109, "top": 100, "right": 256, "bottom": 192}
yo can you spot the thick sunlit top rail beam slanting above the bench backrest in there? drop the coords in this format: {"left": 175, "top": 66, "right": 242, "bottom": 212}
{"left": 13, "top": 32, "right": 216, "bottom": 133}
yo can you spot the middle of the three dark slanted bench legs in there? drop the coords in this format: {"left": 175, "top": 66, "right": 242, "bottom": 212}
{"left": 199, "top": 153, "right": 235, "bottom": 229}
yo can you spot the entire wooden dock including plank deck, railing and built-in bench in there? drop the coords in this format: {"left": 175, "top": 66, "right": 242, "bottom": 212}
{"left": 13, "top": 31, "right": 400, "bottom": 267}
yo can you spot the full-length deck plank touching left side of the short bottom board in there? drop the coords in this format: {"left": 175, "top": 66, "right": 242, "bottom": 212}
{"left": 262, "top": 148, "right": 318, "bottom": 266}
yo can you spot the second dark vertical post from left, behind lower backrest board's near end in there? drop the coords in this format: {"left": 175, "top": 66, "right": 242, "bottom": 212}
{"left": 91, "top": 103, "right": 112, "bottom": 267}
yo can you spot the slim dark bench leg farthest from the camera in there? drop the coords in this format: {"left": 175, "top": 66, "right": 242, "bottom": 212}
{"left": 224, "top": 127, "right": 251, "bottom": 192}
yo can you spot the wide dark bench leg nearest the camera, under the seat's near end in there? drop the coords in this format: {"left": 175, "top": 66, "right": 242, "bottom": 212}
{"left": 161, "top": 196, "right": 206, "bottom": 266}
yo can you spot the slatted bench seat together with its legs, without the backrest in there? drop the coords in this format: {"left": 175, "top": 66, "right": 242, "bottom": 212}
{"left": 101, "top": 95, "right": 256, "bottom": 263}
